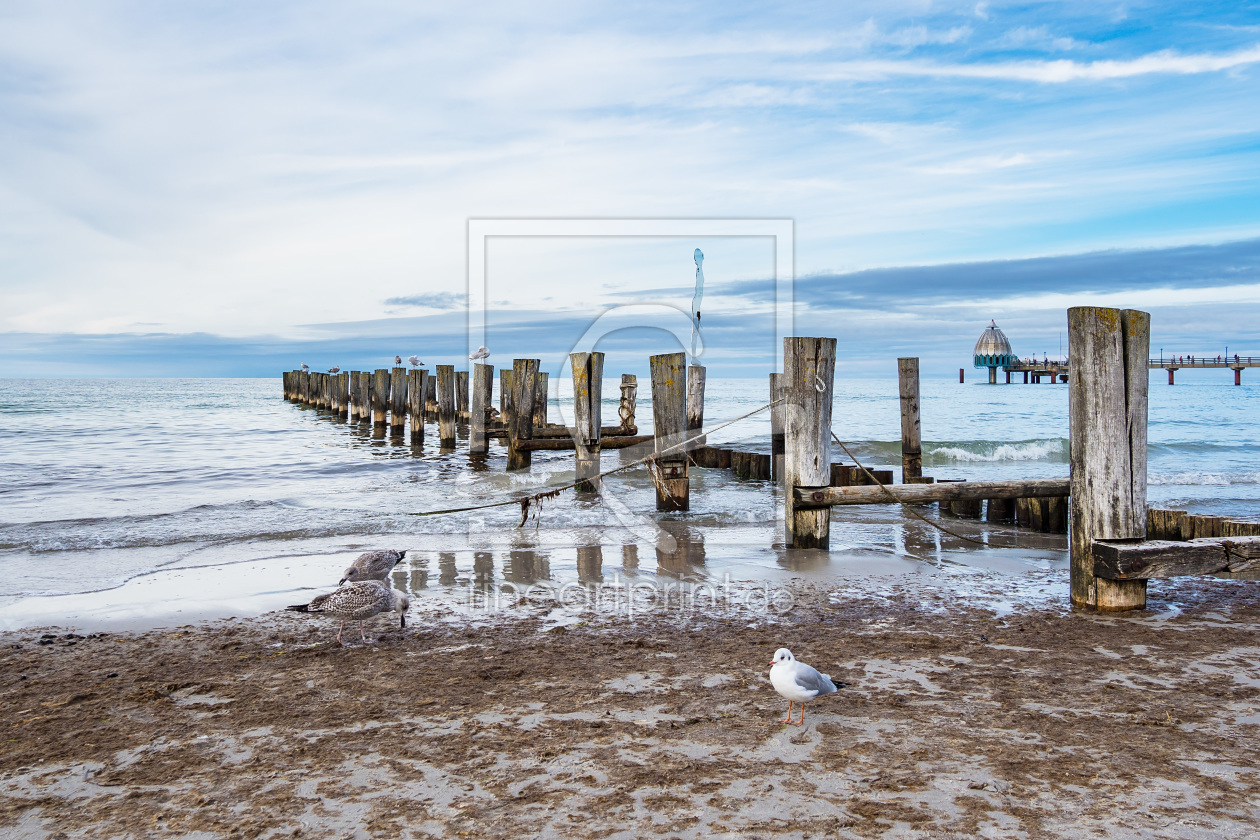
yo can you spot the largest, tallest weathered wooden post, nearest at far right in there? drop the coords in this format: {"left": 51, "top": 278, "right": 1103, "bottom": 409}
{"left": 1067, "top": 306, "right": 1150, "bottom": 610}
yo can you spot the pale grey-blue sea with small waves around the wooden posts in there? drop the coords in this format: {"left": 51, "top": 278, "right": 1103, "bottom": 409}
{"left": 0, "top": 370, "right": 1260, "bottom": 630}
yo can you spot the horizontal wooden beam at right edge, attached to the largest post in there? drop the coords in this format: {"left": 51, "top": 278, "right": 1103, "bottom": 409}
{"left": 1092, "top": 536, "right": 1260, "bottom": 581}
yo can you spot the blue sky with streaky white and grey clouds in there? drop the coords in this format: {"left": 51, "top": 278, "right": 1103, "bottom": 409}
{"left": 0, "top": 0, "right": 1260, "bottom": 378}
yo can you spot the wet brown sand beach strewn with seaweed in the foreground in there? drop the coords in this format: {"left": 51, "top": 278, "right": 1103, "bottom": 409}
{"left": 0, "top": 572, "right": 1260, "bottom": 837}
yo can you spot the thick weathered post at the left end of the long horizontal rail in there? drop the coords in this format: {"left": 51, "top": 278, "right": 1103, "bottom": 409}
{"left": 782, "top": 336, "right": 835, "bottom": 548}
